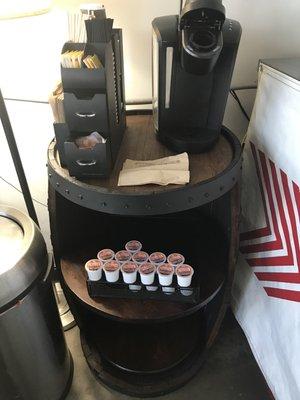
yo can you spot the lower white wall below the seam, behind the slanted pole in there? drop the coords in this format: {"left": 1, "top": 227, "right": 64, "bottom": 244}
{"left": 0, "top": 101, "right": 53, "bottom": 249}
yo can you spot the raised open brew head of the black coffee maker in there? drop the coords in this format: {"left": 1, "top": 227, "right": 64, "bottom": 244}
{"left": 179, "top": 0, "right": 226, "bottom": 75}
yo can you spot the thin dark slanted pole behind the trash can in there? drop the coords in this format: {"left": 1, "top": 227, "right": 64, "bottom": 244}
{"left": 0, "top": 90, "right": 39, "bottom": 226}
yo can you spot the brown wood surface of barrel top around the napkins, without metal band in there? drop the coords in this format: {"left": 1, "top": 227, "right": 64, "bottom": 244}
{"left": 87, "top": 115, "right": 233, "bottom": 194}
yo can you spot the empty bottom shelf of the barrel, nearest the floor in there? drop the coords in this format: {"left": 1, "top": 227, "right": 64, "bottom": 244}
{"left": 81, "top": 313, "right": 207, "bottom": 397}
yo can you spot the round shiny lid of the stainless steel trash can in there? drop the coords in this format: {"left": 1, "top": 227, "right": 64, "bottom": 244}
{"left": 0, "top": 205, "right": 48, "bottom": 312}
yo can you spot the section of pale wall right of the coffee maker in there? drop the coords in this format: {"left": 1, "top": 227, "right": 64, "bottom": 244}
{"left": 223, "top": 0, "right": 300, "bottom": 133}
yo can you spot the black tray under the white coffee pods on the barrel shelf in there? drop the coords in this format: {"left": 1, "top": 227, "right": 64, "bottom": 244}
{"left": 87, "top": 276, "right": 200, "bottom": 304}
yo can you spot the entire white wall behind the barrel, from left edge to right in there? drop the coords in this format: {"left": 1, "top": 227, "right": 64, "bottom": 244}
{"left": 0, "top": 0, "right": 300, "bottom": 245}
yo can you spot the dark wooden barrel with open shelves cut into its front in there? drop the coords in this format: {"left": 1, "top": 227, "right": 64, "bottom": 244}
{"left": 48, "top": 115, "right": 241, "bottom": 397}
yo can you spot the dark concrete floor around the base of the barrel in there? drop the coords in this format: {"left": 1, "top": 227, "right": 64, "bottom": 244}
{"left": 66, "top": 312, "right": 272, "bottom": 400}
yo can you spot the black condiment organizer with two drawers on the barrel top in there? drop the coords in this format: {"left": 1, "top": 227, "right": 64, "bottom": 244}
{"left": 54, "top": 29, "right": 126, "bottom": 179}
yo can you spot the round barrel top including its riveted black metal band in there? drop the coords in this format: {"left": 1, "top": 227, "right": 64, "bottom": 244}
{"left": 48, "top": 115, "right": 241, "bottom": 214}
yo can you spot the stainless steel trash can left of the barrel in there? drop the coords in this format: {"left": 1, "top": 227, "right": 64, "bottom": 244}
{"left": 0, "top": 206, "right": 73, "bottom": 400}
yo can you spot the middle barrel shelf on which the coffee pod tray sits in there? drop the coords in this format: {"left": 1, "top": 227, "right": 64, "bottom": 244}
{"left": 60, "top": 238, "right": 225, "bottom": 322}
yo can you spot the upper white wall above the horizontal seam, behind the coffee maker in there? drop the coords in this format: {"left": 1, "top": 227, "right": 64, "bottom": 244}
{"left": 0, "top": 0, "right": 300, "bottom": 131}
